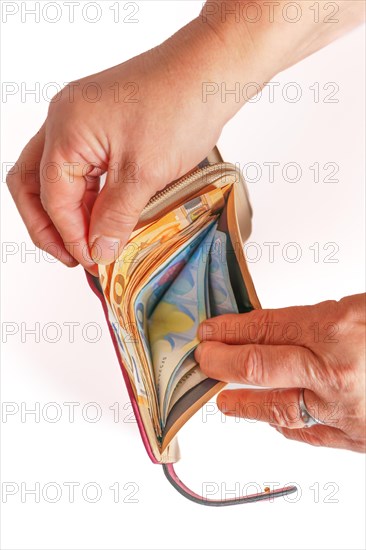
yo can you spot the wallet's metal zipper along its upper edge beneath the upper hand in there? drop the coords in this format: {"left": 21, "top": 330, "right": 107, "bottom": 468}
{"left": 140, "top": 162, "right": 238, "bottom": 222}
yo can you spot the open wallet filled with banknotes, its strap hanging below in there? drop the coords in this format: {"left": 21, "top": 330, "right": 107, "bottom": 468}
{"left": 87, "top": 147, "right": 296, "bottom": 506}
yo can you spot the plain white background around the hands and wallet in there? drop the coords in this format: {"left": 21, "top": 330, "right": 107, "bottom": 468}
{"left": 1, "top": 0, "right": 365, "bottom": 550}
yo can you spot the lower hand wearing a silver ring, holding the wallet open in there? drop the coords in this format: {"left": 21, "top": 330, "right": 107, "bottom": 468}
{"left": 196, "top": 294, "right": 366, "bottom": 451}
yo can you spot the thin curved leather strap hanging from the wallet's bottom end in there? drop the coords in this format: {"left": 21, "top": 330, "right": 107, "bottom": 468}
{"left": 163, "top": 464, "right": 297, "bottom": 506}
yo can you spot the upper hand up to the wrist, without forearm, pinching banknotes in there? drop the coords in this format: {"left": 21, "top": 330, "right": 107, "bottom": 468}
{"left": 7, "top": 20, "right": 236, "bottom": 273}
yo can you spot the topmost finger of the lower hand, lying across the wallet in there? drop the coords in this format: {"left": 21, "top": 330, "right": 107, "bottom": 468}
{"left": 198, "top": 301, "right": 337, "bottom": 345}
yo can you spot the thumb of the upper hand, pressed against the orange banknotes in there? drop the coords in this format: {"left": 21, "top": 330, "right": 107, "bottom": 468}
{"left": 89, "top": 163, "right": 153, "bottom": 265}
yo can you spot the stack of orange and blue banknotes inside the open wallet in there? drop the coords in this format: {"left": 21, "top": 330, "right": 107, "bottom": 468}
{"left": 99, "top": 181, "right": 238, "bottom": 452}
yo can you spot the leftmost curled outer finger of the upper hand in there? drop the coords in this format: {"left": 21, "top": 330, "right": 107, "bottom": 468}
{"left": 7, "top": 125, "right": 78, "bottom": 267}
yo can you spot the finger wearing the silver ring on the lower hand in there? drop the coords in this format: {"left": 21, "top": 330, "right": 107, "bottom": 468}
{"left": 217, "top": 388, "right": 339, "bottom": 430}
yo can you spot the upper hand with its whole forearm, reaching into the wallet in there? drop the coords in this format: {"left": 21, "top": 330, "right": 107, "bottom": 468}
{"left": 7, "top": 0, "right": 364, "bottom": 274}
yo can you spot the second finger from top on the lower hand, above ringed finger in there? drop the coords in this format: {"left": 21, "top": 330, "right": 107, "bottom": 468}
{"left": 195, "top": 342, "right": 318, "bottom": 390}
